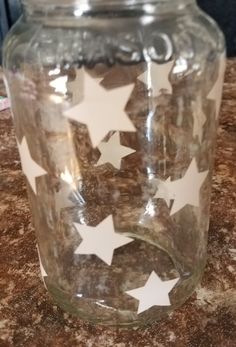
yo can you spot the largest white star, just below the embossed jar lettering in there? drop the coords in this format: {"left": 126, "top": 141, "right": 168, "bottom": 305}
{"left": 64, "top": 73, "right": 136, "bottom": 148}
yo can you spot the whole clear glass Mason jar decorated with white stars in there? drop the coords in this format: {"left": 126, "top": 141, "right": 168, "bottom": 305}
{"left": 4, "top": 0, "right": 225, "bottom": 326}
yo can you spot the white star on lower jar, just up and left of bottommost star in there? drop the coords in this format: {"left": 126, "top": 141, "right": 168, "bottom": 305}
{"left": 74, "top": 216, "right": 134, "bottom": 265}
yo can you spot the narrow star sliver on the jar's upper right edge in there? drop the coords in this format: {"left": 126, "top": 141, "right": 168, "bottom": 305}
{"left": 208, "top": 52, "right": 226, "bottom": 118}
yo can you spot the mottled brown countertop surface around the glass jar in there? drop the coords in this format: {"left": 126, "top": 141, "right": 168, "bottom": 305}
{"left": 0, "top": 60, "right": 236, "bottom": 347}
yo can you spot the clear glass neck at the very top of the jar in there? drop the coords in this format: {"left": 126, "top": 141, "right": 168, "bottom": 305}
{"left": 22, "top": 0, "right": 196, "bottom": 17}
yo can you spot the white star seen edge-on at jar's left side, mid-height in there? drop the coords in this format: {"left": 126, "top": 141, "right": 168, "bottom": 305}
{"left": 17, "top": 137, "right": 47, "bottom": 194}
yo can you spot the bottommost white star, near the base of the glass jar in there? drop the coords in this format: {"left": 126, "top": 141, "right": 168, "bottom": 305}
{"left": 126, "top": 271, "right": 179, "bottom": 314}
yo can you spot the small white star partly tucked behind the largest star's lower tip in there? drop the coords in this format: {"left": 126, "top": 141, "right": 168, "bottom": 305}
{"left": 97, "top": 133, "right": 136, "bottom": 170}
